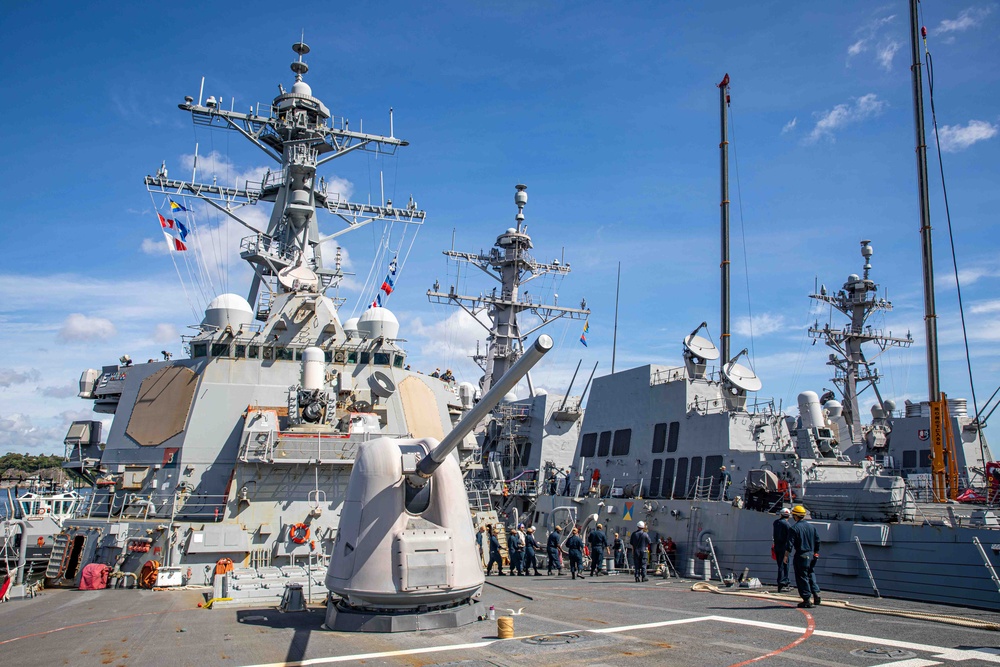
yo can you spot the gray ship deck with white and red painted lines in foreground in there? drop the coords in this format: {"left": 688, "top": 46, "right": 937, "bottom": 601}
{"left": 0, "top": 575, "right": 1000, "bottom": 667}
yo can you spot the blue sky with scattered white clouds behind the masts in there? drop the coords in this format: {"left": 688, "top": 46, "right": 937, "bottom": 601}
{"left": 0, "top": 0, "right": 1000, "bottom": 453}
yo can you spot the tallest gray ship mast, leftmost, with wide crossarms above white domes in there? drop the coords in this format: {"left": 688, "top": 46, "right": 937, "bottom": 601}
{"left": 146, "top": 42, "right": 425, "bottom": 320}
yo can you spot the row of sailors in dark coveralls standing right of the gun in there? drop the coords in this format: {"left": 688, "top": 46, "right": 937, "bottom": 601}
{"left": 476, "top": 521, "right": 677, "bottom": 582}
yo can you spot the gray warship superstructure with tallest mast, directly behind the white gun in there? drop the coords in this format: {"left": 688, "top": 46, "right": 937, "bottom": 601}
{"left": 34, "top": 42, "right": 474, "bottom": 602}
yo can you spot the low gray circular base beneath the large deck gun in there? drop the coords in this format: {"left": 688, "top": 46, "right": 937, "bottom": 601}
{"left": 324, "top": 600, "right": 485, "bottom": 632}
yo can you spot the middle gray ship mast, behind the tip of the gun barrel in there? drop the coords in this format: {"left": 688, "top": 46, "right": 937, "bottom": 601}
{"left": 427, "top": 185, "right": 590, "bottom": 393}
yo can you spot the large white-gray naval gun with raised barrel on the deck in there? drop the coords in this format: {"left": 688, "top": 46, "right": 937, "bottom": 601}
{"left": 325, "top": 334, "right": 552, "bottom": 632}
